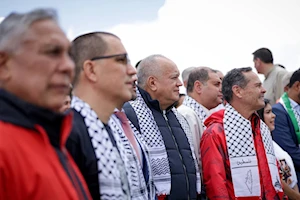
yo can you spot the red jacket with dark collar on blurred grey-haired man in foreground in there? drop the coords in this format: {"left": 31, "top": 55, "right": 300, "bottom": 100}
{"left": 0, "top": 90, "right": 91, "bottom": 200}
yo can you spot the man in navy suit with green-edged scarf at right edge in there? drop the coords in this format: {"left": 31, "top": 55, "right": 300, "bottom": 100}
{"left": 272, "top": 69, "right": 300, "bottom": 187}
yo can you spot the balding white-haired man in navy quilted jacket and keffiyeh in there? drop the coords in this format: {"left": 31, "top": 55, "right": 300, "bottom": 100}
{"left": 125, "top": 55, "right": 200, "bottom": 199}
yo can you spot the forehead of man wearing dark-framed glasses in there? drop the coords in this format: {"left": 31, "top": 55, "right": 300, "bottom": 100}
{"left": 103, "top": 35, "right": 127, "bottom": 55}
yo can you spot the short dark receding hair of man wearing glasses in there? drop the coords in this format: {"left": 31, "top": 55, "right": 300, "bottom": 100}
{"left": 70, "top": 32, "right": 119, "bottom": 87}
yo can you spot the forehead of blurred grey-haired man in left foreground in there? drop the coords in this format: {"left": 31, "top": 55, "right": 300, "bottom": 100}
{"left": 23, "top": 19, "right": 70, "bottom": 47}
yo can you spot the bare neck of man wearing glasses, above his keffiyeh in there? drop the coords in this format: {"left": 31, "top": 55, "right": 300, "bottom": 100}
{"left": 74, "top": 85, "right": 116, "bottom": 124}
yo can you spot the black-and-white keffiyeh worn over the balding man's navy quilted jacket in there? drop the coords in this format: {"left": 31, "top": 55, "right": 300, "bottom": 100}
{"left": 130, "top": 90, "right": 200, "bottom": 195}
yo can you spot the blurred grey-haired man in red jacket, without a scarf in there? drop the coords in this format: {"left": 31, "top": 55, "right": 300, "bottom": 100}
{"left": 0, "top": 9, "right": 91, "bottom": 200}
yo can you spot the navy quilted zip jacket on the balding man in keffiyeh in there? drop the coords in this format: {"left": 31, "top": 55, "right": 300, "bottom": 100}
{"left": 124, "top": 88, "right": 197, "bottom": 200}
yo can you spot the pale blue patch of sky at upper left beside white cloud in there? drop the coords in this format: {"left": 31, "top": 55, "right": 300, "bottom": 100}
{"left": 0, "top": 0, "right": 164, "bottom": 32}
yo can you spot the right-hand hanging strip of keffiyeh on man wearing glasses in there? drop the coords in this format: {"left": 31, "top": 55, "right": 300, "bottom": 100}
{"left": 109, "top": 114, "right": 154, "bottom": 200}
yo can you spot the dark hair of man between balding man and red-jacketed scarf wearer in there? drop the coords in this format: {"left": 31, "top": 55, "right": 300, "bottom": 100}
{"left": 186, "top": 67, "right": 217, "bottom": 93}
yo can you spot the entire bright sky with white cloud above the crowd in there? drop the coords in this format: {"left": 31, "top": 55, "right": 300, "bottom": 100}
{"left": 0, "top": 0, "right": 300, "bottom": 92}
